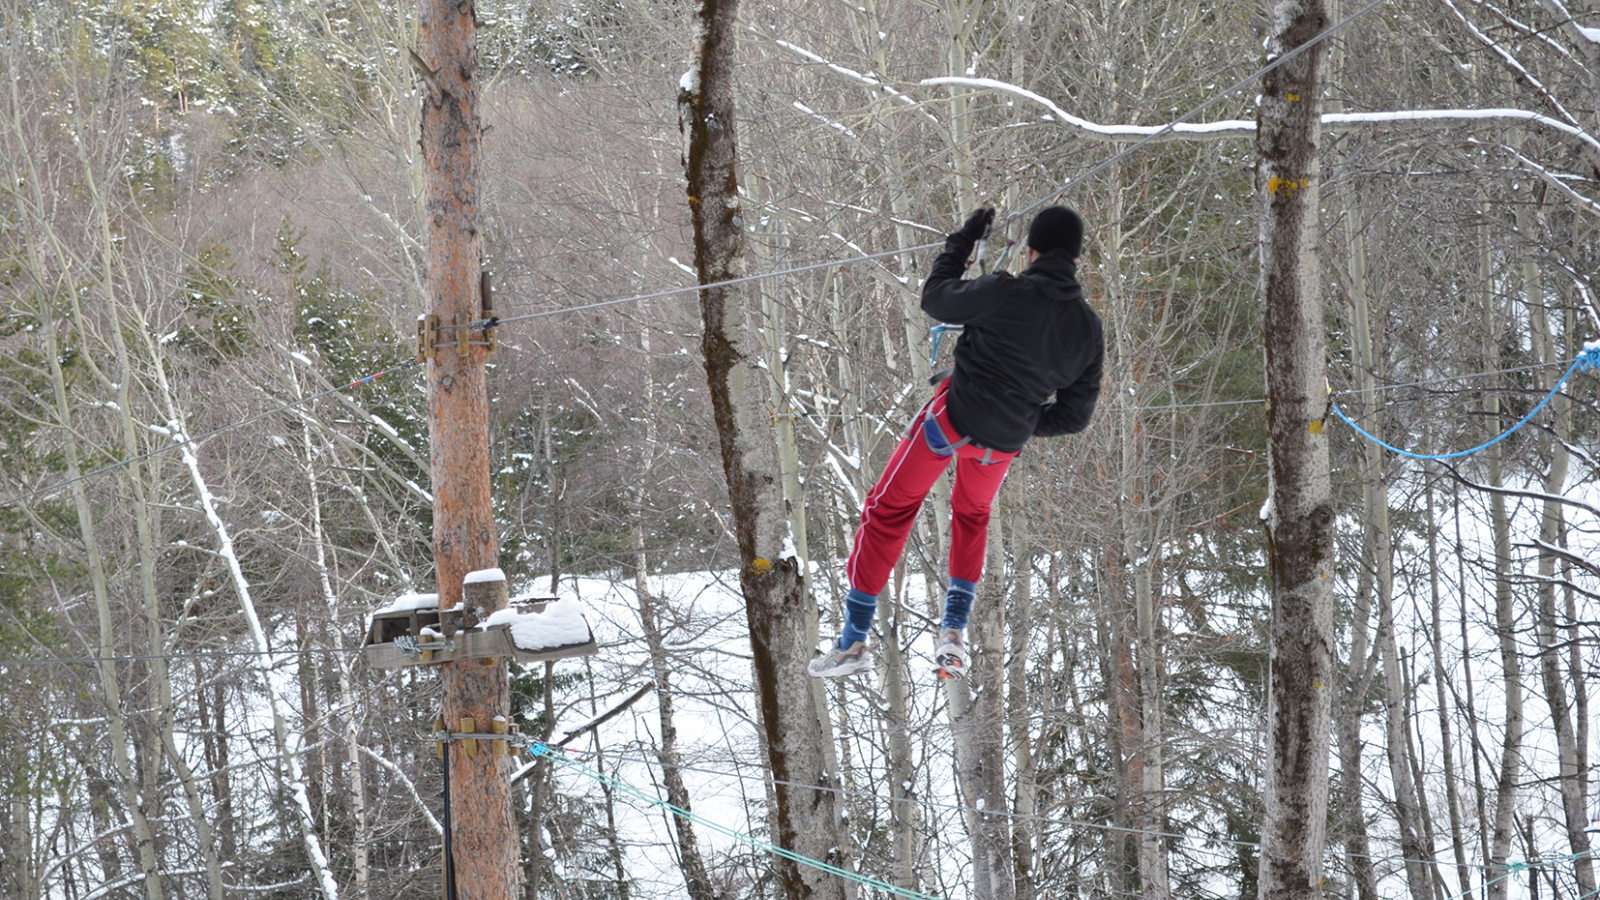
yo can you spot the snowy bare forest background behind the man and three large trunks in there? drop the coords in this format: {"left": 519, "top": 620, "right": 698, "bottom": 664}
{"left": 0, "top": 0, "right": 1600, "bottom": 900}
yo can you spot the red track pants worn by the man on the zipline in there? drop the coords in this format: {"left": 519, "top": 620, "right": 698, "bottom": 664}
{"left": 845, "top": 380, "right": 1016, "bottom": 596}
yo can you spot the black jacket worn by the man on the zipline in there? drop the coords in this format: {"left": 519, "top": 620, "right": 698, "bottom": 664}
{"left": 922, "top": 235, "right": 1106, "bottom": 453}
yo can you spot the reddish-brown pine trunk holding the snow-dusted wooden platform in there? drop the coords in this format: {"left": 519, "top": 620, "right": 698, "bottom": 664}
{"left": 413, "top": 0, "right": 517, "bottom": 900}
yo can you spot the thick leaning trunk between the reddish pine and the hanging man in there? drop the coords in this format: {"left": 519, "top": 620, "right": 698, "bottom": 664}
{"left": 678, "top": 0, "right": 845, "bottom": 900}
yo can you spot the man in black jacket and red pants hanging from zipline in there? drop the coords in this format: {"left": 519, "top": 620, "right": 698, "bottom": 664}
{"left": 808, "top": 207, "right": 1106, "bottom": 677}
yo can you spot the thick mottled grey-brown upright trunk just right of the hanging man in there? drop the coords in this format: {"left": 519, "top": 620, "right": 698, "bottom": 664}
{"left": 1256, "top": 0, "right": 1334, "bottom": 900}
